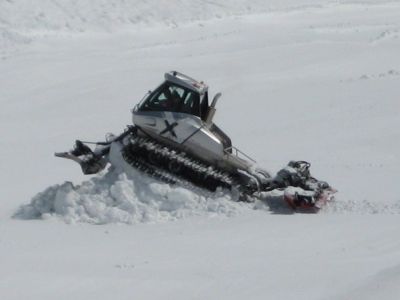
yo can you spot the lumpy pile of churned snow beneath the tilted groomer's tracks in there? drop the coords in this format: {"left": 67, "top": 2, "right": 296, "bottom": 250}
{"left": 15, "top": 171, "right": 251, "bottom": 224}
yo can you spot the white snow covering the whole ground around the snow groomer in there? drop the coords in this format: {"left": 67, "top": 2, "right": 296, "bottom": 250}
{"left": 0, "top": 0, "right": 400, "bottom": 300}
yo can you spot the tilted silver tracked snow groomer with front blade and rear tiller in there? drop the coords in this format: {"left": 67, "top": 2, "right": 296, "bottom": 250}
{"left": 55, "top": 71, "right": 336, "bottom": 212}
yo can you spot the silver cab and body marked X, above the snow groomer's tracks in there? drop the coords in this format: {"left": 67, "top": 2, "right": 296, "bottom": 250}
{"left": 132, "top": 71, "right": 241, "bottom": 169}
